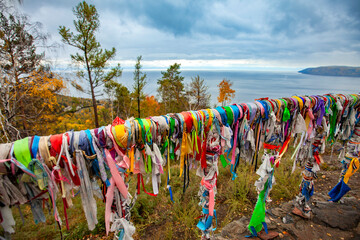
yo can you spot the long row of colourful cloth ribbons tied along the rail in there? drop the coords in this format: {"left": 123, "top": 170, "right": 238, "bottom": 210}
{"left": 0, "top": 94, "right": 360, "bottom": 239}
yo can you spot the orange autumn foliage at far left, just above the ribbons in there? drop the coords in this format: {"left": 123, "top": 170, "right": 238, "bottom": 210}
{"left": 0, "top": 68, "right": 65, "bottom": 141}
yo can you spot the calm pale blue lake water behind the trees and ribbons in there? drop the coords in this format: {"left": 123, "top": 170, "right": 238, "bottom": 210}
{"left": 64, "top": 70, "right": 360, "bottom": 106}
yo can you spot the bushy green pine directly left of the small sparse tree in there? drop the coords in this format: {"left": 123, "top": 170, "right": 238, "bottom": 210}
{"left": 157, "top": 63, "right": 186, "bottom": 112}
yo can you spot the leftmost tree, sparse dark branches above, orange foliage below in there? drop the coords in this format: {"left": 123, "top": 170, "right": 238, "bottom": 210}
{"left": 0, "top": 12, "right": 64, "bottom": 141}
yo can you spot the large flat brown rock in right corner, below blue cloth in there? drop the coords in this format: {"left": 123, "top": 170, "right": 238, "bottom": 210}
{"left": 312, "top": 199, "right": 360, "bottom": 230}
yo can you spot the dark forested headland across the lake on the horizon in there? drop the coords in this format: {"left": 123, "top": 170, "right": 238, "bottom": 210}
{"left": 299, "top": 66, "right": 360, "bottom": 77}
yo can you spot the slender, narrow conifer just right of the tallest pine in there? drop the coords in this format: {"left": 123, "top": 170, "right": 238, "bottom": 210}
{"left": 132, "top": 55, "right": 146, "bottom": 118}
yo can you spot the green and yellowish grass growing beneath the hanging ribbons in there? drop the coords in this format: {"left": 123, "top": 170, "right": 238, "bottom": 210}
{"left": 0, "top": 149, "right": 308, "bottom": 239}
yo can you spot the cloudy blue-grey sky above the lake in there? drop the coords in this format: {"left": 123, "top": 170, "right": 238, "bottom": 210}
{"left": 20, "top": 0, "right": 360, "bottom": 69}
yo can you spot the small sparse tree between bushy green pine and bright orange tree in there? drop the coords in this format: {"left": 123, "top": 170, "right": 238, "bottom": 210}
{"left": 188, "top": 75, "right": 211, "bottom": 110}
